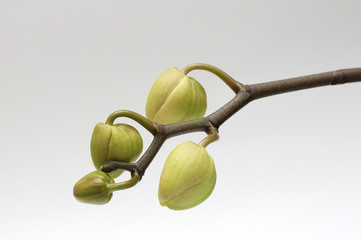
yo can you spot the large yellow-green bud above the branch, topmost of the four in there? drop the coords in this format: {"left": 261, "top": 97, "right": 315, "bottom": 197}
{"left": 146, "top": 67, "right": 207, "bottom": 124}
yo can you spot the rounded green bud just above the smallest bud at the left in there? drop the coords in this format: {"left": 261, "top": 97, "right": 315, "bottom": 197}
{"left": 90, "top": 122, "right": 143, "bottom": 178}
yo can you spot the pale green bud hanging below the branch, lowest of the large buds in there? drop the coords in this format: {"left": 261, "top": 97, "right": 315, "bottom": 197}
{"left": 158, "top": 141, "right": 216, "bottom": 210}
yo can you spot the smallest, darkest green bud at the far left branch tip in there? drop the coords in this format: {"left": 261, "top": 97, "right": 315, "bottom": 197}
{"left": 73, "top": 171, "right": 114, "bottom": 205}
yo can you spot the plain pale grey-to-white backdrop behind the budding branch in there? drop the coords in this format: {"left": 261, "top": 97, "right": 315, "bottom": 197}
{"left": 0, "top": 0, "right": 361, "bottom": 240}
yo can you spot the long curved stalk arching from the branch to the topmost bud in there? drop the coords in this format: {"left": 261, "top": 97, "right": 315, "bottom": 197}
{"left": 182, "top": 63, "right": 245, "bottom": 93}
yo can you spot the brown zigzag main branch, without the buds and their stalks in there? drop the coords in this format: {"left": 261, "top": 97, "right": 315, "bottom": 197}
{"left": 102, "top": 68, "right": 361, "bottom": 177}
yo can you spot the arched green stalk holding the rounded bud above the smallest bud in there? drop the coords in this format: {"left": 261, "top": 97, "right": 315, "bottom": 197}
{"left": 106, "top": 110, "right": 158, "bottom": 136}
